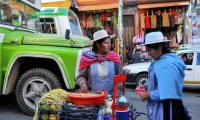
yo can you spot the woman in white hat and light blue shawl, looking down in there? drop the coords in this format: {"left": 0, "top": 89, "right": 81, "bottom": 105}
{"left": 136, "top": 32, "right": 190, "bottom": 120}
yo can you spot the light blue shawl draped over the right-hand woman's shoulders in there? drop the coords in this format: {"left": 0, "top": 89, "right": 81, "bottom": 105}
{"left": 146, "top": 53, "right": 186, "bottom": 100}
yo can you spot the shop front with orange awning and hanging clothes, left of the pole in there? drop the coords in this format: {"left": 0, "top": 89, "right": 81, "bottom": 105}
{"left": 77, "top": 0, "right": 118, "bottom": 50}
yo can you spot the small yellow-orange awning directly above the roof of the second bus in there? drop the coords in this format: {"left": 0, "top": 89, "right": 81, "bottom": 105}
{"left": 41, "top": 0, "right": 71, "bottom": 8}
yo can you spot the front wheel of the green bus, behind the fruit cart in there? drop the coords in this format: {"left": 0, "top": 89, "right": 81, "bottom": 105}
{"left": 15, "top": 68, "right": 61, "bottom": 116}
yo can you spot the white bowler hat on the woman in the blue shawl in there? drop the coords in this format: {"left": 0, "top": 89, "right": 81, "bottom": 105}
{"left": 142, "top": 32, "right": 172, "bottom": 45}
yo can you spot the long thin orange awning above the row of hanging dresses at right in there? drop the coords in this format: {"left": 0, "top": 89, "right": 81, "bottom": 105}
{"left": 138, "top": 1, "right": 189, "bottom": 9}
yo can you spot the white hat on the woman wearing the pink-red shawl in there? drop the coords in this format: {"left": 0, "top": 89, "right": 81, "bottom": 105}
{"left": 93, "top": 30, "right": 116, "bottom": 41}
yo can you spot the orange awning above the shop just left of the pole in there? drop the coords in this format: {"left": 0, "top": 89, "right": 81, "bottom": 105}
{"left": 76, "top": 0, "right": 118, "bottom": 11}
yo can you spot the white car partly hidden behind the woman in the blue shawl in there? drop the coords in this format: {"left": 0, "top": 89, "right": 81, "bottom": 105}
{"left": 123, "top": 49, "right": 200, "bottom": 86}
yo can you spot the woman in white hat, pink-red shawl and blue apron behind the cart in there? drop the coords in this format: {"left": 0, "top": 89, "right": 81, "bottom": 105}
{"left": 76, "top": 30, "right": 123, "bottom": 95}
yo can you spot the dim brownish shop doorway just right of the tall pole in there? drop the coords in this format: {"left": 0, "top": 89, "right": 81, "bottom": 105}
{"left": 123, "top": 15, "right": 135, "bottom": 62}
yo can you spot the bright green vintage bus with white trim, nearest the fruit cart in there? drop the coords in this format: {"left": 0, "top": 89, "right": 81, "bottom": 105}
{"left": 0, "top": 0, "right": 91, "bottom": 115}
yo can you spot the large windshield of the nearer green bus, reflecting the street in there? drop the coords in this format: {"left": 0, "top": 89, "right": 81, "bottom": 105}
{"left": 0, "top": 0, "right": 39, "bottom": 31}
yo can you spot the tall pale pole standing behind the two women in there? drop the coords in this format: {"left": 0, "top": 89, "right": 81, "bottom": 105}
{"left": 118, "top": 0, "right": 124, "bottom": 64}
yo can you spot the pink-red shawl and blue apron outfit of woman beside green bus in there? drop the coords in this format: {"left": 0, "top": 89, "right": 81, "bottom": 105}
{"left": 76, "top": 52, "right": 123, "bottom": 96}
